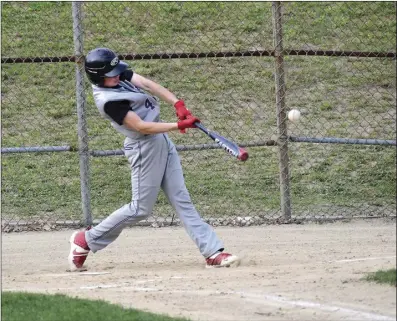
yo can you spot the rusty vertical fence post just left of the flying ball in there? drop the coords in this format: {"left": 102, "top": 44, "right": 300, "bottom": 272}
{"left": 272, "top": 1, "right": 291, "bottom": 220}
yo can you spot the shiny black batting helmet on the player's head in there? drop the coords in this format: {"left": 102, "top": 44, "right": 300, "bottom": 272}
{"left": 85, "top": 48, "right": 128, "bottom": 86}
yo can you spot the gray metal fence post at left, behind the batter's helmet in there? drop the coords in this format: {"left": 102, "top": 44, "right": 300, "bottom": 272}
{"left": 72, "top": 1, "right": 92, "bottom": 226}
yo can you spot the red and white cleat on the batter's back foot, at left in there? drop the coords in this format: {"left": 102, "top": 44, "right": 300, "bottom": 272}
{"left": 68, "top": 231, "right": 90, "bottom": 272}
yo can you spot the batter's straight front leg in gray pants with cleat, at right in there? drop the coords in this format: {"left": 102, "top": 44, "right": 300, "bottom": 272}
{"left": 161, "top": 137, "right": 239, "bottom": 267}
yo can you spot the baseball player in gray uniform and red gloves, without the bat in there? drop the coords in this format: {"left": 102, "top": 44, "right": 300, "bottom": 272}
{"left": 68, "top": 48, "right": 239, "bottom": 271}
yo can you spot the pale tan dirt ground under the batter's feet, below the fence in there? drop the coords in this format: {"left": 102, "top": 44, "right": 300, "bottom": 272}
{"left": 2, "top": 220, "right": 396, "bottom": 321}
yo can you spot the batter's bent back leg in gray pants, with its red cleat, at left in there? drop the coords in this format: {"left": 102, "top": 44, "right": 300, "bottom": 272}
{"left": 69, "top": 136, "right": 168, "bottom": 271}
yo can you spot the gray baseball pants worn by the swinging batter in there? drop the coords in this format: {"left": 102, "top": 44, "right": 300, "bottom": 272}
{"left": 85, "top": 134, "right": 224, "bottom": 258}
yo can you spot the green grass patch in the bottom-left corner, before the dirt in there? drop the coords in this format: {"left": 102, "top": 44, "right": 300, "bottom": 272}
{"left": 1, "top": 292, "right": 188, "bottom": 321}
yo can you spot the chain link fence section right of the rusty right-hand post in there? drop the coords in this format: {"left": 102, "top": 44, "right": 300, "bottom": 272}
{"left": 283, "top": 2, "right": 396, "bottom": 219}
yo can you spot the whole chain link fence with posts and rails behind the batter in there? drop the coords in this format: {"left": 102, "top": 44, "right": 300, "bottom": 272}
{"left": 1, "top": 2, "right": 396, "bottom": 232}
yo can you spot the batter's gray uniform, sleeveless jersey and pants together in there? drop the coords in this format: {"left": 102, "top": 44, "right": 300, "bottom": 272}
{"left": 85, "top": 81, "right": 223, "bottom": 258}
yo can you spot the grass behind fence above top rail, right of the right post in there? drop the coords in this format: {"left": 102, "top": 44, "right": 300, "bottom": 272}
{"left": 283, "top": 1, "right": 396, "bottom": 51}
